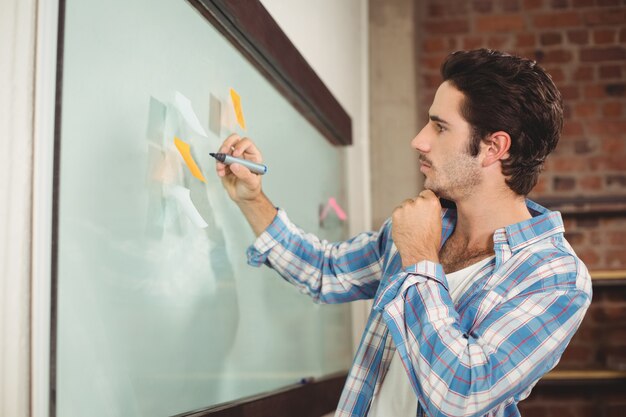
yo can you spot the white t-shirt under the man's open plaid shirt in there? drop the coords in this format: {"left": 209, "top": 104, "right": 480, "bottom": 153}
{"left": 367, "top": 256, "right": 494, "bottom": 417}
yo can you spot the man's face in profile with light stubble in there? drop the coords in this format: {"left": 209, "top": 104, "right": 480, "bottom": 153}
{"left": 411, "top": 82, "right": 481, "bottom": 201}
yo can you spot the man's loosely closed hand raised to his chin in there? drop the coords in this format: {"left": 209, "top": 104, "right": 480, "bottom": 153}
{"left": 391, "top": 190, "right": 442, "bottom": 267}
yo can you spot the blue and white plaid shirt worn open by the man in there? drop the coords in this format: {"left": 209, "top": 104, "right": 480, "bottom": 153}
{"left": 248, "top": 200, "right": 591, "bottom": 417}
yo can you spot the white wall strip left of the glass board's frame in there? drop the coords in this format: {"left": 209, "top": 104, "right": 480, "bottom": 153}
{"left": 0, "top": 0, "right": 37, "bottom": 417}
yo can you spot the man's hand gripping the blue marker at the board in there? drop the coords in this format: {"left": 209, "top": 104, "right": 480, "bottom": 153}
{"left": 217, "top": 134, "right": 263, "bottom": 204}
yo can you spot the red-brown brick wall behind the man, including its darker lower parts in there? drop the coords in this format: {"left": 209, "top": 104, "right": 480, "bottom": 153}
{"left": 416, "top": 0, "right": 626, "bottom": 416}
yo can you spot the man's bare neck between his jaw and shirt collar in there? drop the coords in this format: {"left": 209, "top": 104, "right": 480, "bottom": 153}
{"left": 446, "top": 193, "right": 532, "bottom": 248}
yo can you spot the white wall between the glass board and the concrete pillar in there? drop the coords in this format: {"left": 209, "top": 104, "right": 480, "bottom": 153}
{"left": 261, "top": 0, "right": 372, "bottom": 354}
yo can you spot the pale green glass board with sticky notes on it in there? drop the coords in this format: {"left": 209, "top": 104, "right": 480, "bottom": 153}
{"left": 56, "top": 0, "right": 352, "bottom": 417}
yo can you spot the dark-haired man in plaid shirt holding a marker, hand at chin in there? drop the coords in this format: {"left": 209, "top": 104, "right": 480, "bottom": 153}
{"left": 212, "top": 50, "right": 591, "bottom": 417}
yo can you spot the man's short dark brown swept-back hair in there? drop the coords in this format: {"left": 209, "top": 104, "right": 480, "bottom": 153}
{"left": 441, "top": 49, "right": 563, "bottom": 196}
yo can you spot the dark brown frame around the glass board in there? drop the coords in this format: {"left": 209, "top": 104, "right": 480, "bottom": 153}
{"left": 49, "top": 0, "right": 352, "bottom": 417}
